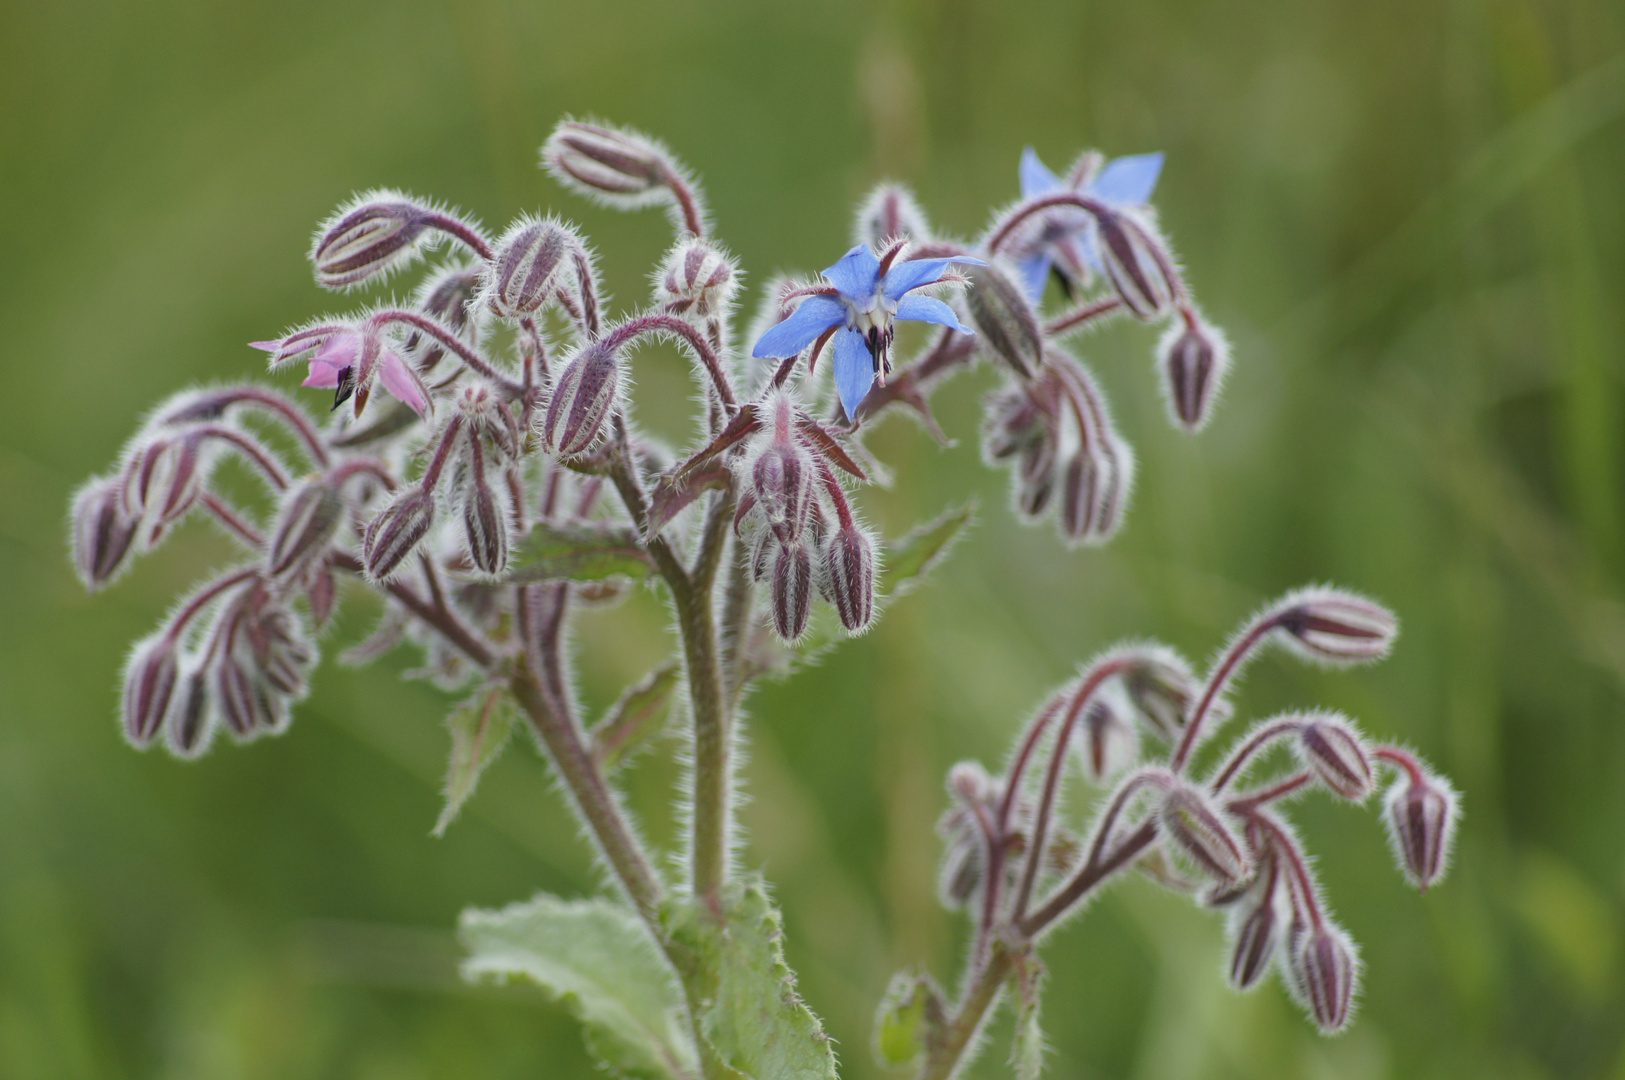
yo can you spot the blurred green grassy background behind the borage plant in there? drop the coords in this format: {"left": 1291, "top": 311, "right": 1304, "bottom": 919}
{"left": 0, "top": 0, "right": 1625, "bottom": 1080}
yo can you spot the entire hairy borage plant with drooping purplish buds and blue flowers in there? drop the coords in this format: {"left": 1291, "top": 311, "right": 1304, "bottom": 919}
{"left": 73, "top": 122, "right": 1456, "bottom": 1080}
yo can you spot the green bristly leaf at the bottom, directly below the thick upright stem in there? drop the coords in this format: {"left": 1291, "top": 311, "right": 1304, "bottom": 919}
{"left": 661, "top": 877, "right": 835, "bottom": 1080}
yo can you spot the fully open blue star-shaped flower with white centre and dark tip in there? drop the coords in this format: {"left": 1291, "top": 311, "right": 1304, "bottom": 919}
{"left": 751, "top": 244, "right": 986, "bottom": 421}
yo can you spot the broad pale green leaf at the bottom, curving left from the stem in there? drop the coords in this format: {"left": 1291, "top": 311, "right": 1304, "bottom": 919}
{"left": 460, "top": 895, "right": 699, "bottom": 1080}
